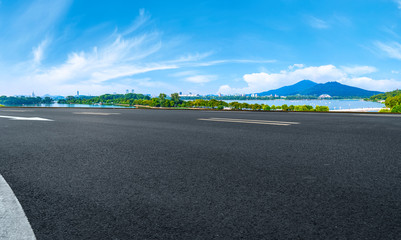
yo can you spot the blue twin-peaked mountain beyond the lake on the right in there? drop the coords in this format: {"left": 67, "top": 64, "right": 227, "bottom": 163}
{"left": 258, "top": 80, "right": 382, "bottom": 97}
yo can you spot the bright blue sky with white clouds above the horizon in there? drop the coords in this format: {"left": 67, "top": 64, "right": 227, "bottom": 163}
{"left": 0, "top": 0, "right": 401, "bottom": 95}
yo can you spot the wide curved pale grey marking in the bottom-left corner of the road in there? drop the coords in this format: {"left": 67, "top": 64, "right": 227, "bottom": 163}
{"left": 0, "top": 175, "right": 36, "bottom": 240}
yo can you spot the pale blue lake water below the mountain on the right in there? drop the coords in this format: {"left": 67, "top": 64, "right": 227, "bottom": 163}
{"left": 226, "top": 99, "right": 385, "bottom": 110}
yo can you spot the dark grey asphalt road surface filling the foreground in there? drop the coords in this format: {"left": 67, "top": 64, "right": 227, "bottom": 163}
{"left": 0, "top": 108, "right": 401, "bottom": 239}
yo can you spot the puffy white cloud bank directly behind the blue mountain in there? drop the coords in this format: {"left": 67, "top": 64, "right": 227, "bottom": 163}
{"left": 218, "top": 65, "right": 401, "bottom": 94}
